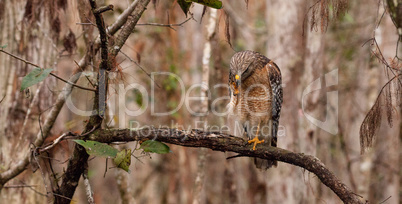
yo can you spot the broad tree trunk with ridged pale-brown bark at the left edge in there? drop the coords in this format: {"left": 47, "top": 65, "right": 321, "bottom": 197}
{"left": 0, "top": 0, "right": 60, "bottom": 203}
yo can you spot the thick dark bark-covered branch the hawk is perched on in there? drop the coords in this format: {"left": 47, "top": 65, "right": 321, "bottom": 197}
{"left": 89, "top": 128, "right": 363, "bottom": 203}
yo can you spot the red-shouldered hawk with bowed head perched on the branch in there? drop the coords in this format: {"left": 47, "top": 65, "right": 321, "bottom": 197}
{"left": 228, "top": 50, "right": 283, "bottom": 169}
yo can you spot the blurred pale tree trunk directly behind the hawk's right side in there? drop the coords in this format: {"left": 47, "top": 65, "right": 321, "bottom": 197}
{"left": 265, "top": 0, "right": 310, "bottom": 203}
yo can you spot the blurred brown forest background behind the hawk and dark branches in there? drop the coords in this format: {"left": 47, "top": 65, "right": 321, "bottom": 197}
{"left": 0, "top": 0, "right": 402, "bottom": 203}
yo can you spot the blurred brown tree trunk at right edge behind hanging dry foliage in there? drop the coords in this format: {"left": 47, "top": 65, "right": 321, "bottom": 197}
{"left": 368, "top": 4, "right": 402, "bottom": 203}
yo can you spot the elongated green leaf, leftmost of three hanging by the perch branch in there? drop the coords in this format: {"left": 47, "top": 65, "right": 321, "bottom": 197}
{"left": 74, "top": 140, "right": 118, "bottom": 157}
